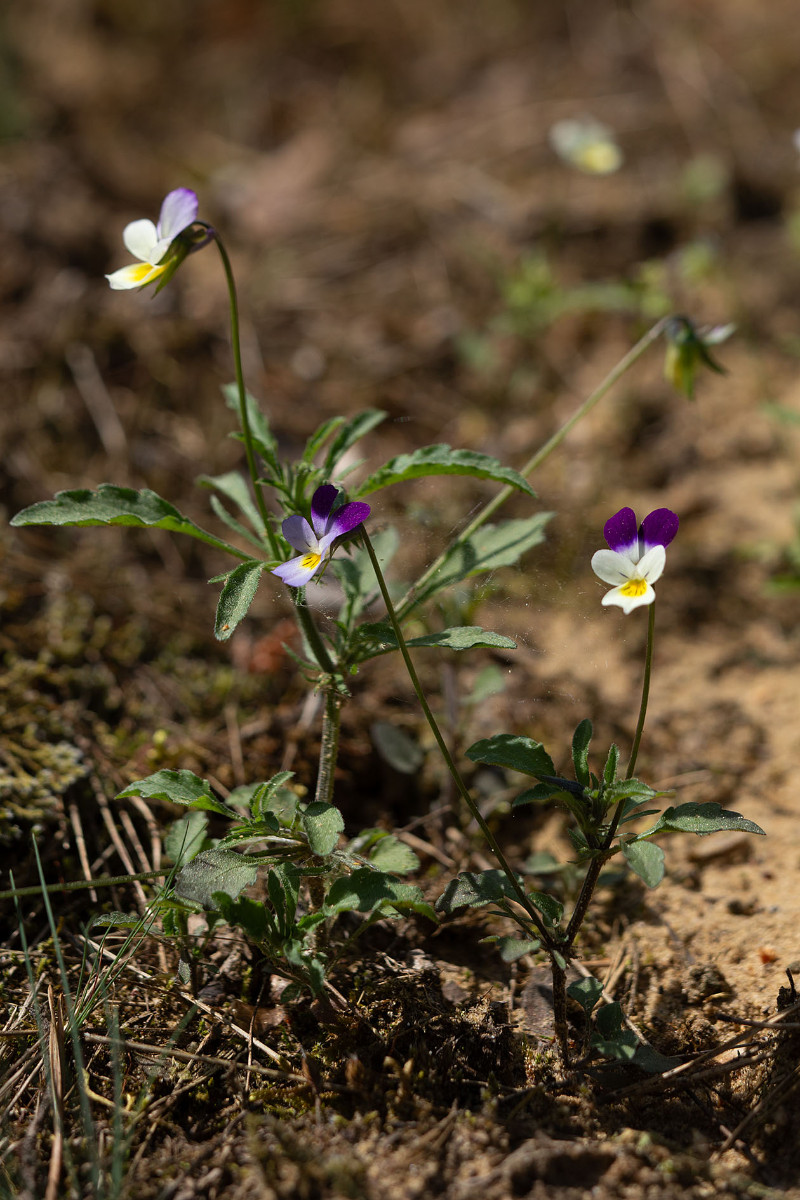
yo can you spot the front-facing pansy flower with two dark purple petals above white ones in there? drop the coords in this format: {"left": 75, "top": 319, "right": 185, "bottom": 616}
{"left": 591, "top": 509, "right": 679, "bottom": 614}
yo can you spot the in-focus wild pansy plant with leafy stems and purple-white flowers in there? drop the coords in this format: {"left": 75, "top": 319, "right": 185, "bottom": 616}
{"left": 12, "top": 188, "right": 760, "bottom": 1063}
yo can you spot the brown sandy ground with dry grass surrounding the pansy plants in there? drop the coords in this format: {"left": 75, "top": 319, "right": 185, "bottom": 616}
{"left": 0, "top": 0, "right": 800, "bottom": 1200}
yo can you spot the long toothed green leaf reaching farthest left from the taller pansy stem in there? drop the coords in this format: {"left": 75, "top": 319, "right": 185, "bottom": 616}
{"left": 11, "top": 484, "right": 249, "bottom": 558}
